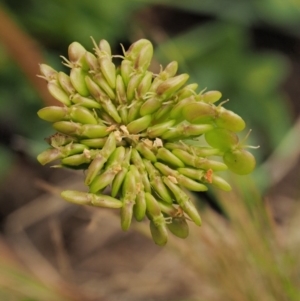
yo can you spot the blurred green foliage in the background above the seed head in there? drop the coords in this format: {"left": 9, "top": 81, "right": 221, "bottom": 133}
{"left": 0, "top": 0, "right": 300, "bottom": 300}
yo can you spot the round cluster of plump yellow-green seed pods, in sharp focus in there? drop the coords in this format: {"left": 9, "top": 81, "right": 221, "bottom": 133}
{"left": 38, "top": 39, "right": 255, "bottom": 245}
